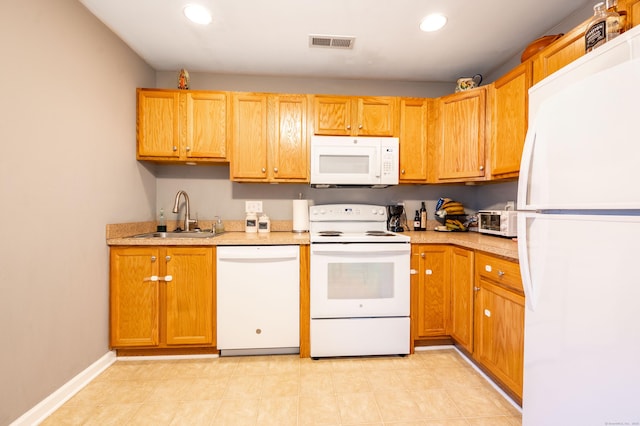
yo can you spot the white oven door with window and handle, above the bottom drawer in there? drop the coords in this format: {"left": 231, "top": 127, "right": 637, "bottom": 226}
{"left": 310, "top": 243, "right": 411, "bottom": 318}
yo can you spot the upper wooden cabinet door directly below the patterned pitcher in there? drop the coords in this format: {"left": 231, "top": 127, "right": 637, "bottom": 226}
{"left": 438, "top": 87, "right": 486, "bottom": 181}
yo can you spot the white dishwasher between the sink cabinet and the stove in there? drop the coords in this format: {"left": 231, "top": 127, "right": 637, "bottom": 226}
{"left": 216, "top": 246, "right": 300, "bottom": 356}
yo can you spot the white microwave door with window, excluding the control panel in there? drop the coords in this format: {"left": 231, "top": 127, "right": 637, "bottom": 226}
{"left": 311, "top": 146, "right": 380, "bottom": 185}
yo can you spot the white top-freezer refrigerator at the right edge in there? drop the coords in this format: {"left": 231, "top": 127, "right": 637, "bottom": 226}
{"left": 517, "top": 28, "right": 640, "bottom": 426}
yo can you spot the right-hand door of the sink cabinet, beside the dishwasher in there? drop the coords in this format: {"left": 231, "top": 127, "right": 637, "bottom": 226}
{"left": 162, "top": 247, "right": 215, "bottom": 345}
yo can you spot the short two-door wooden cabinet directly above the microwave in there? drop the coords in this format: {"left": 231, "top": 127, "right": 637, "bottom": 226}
{"left": 313, "top": 95, "right": 398, "bottom": 136}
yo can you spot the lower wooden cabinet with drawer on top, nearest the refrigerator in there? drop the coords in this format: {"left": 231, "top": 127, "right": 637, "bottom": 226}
{"left": 473, "top": 254, "right": 525, "bottom": 402}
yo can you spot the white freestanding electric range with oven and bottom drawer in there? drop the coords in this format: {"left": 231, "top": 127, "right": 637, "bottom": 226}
{"left": 309, "top": 204, "right": 411, "bottom": 358}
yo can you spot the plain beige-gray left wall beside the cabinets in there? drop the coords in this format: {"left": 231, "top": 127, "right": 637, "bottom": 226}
{"left": 0, "top": 0, "right": 156, "bottom": 425}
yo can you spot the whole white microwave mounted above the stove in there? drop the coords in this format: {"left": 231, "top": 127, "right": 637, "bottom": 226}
{"left": 311, "top": 136, "right": 399, "bottom": 188}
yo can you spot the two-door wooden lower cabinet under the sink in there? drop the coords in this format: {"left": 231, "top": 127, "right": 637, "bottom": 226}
{"left": 110, "top": 246, "right": 216, "bottom": 349}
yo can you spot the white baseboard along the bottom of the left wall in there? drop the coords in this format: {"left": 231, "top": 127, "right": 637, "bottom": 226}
{"left": 11, "top": 351, "right": 116, "bottom": 426}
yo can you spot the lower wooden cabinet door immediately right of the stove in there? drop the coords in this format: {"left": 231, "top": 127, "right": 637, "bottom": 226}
{"left": 415, "top": 245, "right": 451, "bottom": 338}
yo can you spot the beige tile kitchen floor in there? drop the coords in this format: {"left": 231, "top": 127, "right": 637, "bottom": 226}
{"left": 42, "top": 349, "right": 521, "bottom": 426}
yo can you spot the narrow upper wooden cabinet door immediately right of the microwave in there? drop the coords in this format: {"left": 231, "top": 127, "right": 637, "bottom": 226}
{"left": 399, "top": 98, "right": 429, "bottom": 182}
